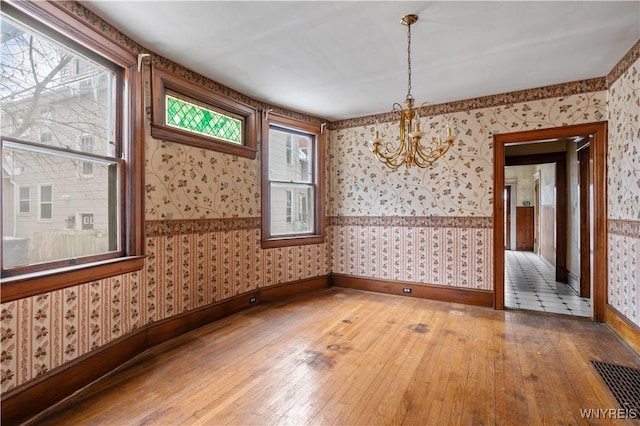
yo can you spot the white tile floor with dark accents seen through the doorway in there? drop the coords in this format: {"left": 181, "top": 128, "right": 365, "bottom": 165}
{"left": 504, "top": 250, "right": 591, "bottom": 317}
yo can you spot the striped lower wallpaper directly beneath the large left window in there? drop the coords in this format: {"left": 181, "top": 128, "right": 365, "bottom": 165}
{"left": 0, "top": 272, "right": 146, "bottom": 393}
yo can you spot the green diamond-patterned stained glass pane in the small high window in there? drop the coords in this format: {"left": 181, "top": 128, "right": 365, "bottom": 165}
{"left": 166, "top": 95, "right": 242, "bottom": 144}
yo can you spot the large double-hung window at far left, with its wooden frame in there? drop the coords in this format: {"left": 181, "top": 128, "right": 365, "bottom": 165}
{"left": 0, "top": 2, "right": 144, "bottom": 290}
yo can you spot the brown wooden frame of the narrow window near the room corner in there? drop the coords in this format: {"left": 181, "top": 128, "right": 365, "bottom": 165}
{"left": 261, "top": 113, "right": 326, "bottom": 248}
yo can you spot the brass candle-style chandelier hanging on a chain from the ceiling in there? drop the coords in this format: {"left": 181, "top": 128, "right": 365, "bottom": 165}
{"left": 369, "top": 15, "right": 453, "bottom": 170}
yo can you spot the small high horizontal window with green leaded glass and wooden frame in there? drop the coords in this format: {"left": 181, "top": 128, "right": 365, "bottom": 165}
{"left": 151, "top": 68, "right": 257, "bottom": 158}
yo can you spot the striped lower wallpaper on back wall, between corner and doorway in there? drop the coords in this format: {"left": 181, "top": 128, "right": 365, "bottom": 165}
{"left": 332, "top": 225, "right": 493, "bottom": 290}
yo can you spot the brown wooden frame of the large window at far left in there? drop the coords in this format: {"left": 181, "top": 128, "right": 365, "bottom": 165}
{"left": 0, "top": 0, "right": 144, "bottom": 303}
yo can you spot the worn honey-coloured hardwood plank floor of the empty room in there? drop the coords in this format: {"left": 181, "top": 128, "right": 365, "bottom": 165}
{"left": 35, "top": 288, "right": 640, "bottom": 425}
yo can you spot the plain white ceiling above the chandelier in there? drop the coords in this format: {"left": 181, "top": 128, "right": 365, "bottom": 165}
{"left": 82, "top": 0, "right": 640, "bottom": 120}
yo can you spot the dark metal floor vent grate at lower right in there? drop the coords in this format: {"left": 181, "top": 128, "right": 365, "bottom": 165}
{"left": 591, "top": 361, "right": 640, "bottom": 412}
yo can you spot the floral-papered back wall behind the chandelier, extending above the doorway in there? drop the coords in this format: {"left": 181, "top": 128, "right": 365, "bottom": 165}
{"left": 329, "top": 92, "right": 606, "bottom": 290}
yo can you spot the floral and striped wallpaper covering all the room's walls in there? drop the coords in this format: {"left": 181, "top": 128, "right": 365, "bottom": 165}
{"left": 0, "top": 2, "right": 640, "bottom": 400}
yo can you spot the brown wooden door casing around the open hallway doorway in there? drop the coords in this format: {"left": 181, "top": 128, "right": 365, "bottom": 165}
{"left": 493, "top": 121, "right": 608, "bottom": 322}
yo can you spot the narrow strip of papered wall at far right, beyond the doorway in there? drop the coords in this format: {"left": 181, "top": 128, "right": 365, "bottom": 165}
{"left": 595, "top": 52, "right": 640, "bottom": 327}
